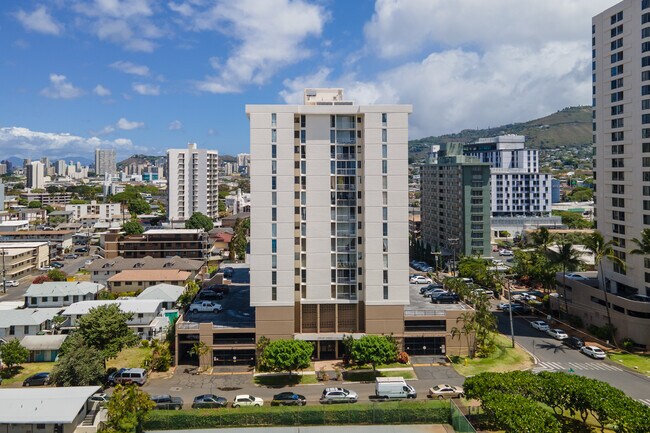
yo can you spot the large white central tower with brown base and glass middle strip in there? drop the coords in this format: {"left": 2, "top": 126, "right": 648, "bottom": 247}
{"left": 246, "top": 89, "right": 412, "bottom": 357}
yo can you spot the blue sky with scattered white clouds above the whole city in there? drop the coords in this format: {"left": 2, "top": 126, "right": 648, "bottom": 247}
{"left": 0, "top": 0, "right": 617, "bottom": 159}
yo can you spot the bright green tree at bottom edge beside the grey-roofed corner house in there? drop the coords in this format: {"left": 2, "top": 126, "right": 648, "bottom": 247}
{"left": 102, "top": 384, "right": 155, "bottom": 433}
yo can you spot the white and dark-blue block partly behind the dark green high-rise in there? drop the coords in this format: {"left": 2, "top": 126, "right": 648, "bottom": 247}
{"left": 464, "top": 134, "right": 551, "bottom": 218}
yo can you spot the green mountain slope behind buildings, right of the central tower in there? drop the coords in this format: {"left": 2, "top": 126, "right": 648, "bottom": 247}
{"left": 409, "top": 106, "right": 592, "bottom": 161}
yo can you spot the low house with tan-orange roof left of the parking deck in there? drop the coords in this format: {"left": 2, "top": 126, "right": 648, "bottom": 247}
{"left": 108, "top": 269, "right": 192, "bottom": 293}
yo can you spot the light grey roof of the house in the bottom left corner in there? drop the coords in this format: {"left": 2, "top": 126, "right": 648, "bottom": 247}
{"left": 0, "top": 386, "right": 99, "bottom": 424}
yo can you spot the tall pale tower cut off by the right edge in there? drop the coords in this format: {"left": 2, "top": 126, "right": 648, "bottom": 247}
{"left": 591, "top": 0, "right": 650, "bottom": 295}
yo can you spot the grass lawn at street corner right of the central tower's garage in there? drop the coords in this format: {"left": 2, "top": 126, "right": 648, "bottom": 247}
{"left": 452, "top": 334, "right": 533, "bottom": 376}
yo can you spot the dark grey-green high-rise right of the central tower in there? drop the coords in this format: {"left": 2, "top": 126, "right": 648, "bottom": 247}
{"left": 420, "top": 143, "right": 491, "bottom": 257}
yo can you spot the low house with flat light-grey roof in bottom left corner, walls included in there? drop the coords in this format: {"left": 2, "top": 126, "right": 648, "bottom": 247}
{"left": 0, "top": 386, "right": 105, "bottom": 433}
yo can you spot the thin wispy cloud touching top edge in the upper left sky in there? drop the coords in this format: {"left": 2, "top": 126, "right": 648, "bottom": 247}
{"left": 73, "top": 0, "right": 166, "bottom": 52}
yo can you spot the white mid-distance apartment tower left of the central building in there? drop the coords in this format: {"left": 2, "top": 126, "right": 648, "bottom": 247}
{"left": 167, "top": 143, "right": 219, "bottom": 222}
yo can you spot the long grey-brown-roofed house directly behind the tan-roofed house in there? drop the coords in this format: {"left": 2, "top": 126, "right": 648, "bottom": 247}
{"left": 86, "top": 256, "right": 205, "bottom": 285}
